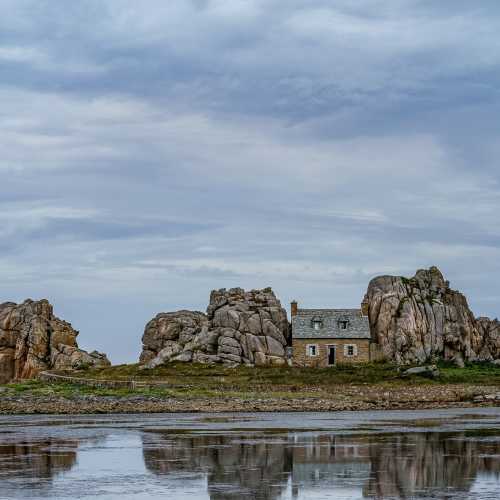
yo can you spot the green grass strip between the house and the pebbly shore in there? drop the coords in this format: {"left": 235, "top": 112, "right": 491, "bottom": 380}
{"left": 0, "top": 362, "right": 500, "bottom": 399}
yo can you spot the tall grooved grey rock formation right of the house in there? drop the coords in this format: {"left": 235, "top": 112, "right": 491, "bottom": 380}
{"left": 365, "top": 267, "right": 500, "bottom": 365}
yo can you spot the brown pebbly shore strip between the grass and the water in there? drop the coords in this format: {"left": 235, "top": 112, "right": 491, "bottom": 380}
{"left": 0, "top": 385, "right": 500, "bottom": 414}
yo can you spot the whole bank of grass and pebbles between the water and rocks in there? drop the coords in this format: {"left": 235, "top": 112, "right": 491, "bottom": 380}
{"left": 0, "top": 363, "right": 500, "bottom": 414}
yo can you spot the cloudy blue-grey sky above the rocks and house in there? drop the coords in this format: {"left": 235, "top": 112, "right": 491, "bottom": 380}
{"left": 0, "top": 0, "right": 500, "bottom": 363}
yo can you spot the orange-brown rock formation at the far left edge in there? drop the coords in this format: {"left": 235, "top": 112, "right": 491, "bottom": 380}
{"left": 0, "top": 300, "right": 110, "bottom": 383}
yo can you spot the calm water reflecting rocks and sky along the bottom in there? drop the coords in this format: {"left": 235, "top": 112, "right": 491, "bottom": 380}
{"left": 0, "top": 408, "right": 500, "bottom": 500}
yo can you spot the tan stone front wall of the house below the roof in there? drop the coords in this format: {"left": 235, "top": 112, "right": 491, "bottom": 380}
{"left": 292, "top": 339, "right": 370, "bottom": 367}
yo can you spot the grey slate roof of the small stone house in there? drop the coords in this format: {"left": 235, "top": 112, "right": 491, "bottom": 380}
{"left": 292, "top": 309, "right": 371, "bottom": 339}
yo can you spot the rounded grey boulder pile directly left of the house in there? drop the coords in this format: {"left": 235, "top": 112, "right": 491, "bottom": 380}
{"left": 140, "top": 288, "right": 289, "bottom": 368}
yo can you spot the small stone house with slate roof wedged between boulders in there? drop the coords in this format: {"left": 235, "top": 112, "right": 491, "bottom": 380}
{"left": 291, "top": 302, "right": 372, "bottom": 367}
